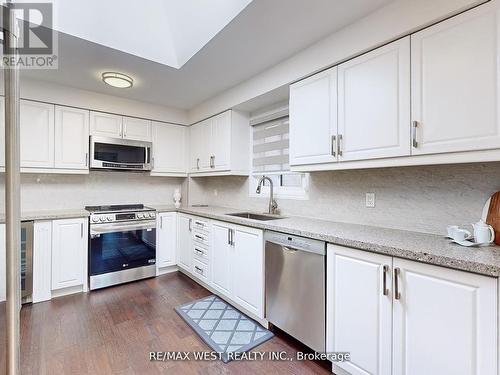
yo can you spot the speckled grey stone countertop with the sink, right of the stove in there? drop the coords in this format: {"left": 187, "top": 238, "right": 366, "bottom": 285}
{"left": 153, "top": 205, "right": 500, "bottom": 277}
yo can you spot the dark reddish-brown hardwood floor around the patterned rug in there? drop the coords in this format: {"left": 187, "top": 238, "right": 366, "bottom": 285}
{"left": 0, "top": 273, "right": 330, "bottom": 375}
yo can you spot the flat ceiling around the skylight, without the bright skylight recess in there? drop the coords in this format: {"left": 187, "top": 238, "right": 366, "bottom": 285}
{"left": 21, "top": 0, "right": 392, "bottom": 109}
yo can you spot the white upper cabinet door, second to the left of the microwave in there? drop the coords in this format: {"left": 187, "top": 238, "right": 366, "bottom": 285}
{"left": 20, "top": 100, "right": 54, "bottom": 168}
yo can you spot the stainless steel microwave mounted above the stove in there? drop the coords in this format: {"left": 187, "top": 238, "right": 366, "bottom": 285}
{"left": 90, "top": 136, "right": 152, "bottom": 171}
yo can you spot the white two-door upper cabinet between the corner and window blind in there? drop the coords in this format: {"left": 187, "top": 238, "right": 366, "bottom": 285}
{"left": 189, "top": 110, "right": 250, "bottom": 176}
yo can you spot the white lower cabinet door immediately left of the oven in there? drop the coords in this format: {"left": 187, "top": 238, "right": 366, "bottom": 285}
{"left": 52, "top": 219, "right": 87, "bottom": 290}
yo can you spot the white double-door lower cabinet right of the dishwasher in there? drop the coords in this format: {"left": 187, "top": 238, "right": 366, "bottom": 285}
{"left": 327, "top": 244, "right": 498, "bottom": 375}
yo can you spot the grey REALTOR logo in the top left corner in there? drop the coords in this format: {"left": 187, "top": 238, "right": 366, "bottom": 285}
{"left": 1, "top": 3, "right": 57, "bottom": 69}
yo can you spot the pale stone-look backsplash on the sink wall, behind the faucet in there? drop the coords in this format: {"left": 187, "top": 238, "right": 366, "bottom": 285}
{"left": 189, "top": 162, "right": 500, "bottom": 234}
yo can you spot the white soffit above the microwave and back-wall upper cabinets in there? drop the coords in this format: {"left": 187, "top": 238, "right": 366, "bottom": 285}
{"left": 13, "top": 79, "right": 188, "bottom": 125}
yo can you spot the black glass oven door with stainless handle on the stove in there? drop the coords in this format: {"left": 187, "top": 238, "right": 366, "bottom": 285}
{"left": 89, "top": 220, "right": 156, "bottom": 276}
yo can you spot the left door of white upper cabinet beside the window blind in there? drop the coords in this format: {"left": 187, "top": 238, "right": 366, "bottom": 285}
{"left": 189, "top": 120, "right": 210, "bottom": 173}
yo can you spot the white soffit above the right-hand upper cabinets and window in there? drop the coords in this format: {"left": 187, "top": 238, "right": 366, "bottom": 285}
{"left": 189, "top": 0, "right": 484, "bottom": 123}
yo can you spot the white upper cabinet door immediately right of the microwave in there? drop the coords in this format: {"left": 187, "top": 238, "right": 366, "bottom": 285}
{"left": 152, "top": 122, "right": 187, "bottom": 173}
